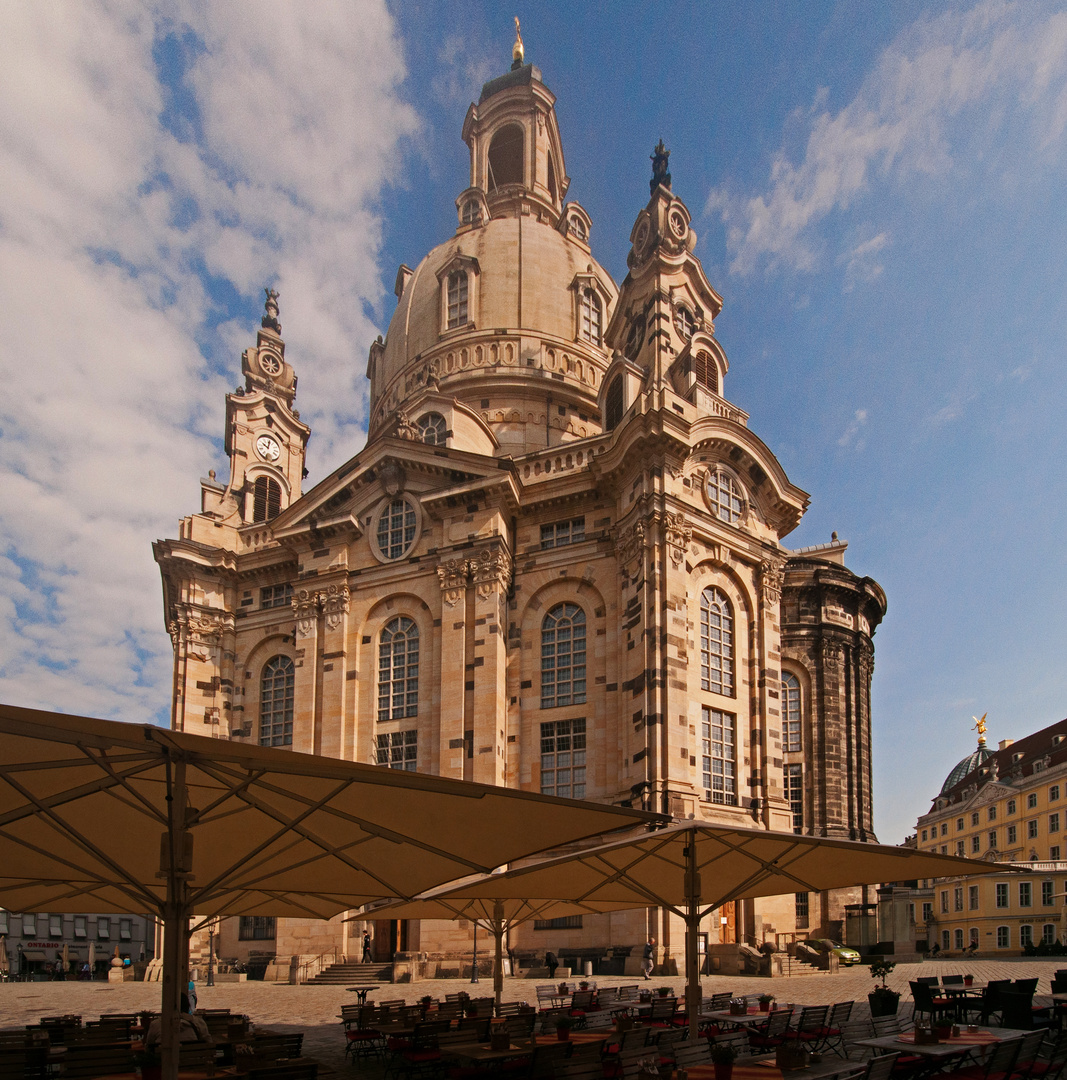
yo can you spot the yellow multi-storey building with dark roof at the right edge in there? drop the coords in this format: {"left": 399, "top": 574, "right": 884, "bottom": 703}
{"left": 909, "top": 720, "right": 1067, "bottom": 955}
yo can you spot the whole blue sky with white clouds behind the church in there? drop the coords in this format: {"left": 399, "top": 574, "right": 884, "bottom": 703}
{"left": 0, "top": 0, "right": 1067, "bottom": 841}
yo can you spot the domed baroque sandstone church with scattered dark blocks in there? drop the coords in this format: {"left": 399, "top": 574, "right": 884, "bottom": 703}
{"left": 154, "top": 41, "right": 886, "bottom": 971}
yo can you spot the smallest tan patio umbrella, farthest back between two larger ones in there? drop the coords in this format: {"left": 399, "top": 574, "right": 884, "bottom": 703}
{"left": 352, "top": 874, "right": 638, "bottom": 1005}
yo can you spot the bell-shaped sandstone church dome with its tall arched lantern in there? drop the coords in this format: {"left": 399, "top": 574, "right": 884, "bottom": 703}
{"left": 367, "top": 56, "right": 619, "bottom": 456}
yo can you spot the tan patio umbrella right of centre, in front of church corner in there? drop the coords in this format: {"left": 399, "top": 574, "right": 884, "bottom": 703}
{"left": 384, "top": 821, "right": 1023, "bottom": 1036}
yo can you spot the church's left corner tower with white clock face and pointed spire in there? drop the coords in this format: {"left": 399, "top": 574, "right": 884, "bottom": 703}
{"left": 203, "top": 288, "right": 311, "bottom": 525}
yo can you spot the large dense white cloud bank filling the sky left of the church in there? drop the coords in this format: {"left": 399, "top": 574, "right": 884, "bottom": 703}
{"left": 0, "top": 6, "right": 417, "bottom": 720}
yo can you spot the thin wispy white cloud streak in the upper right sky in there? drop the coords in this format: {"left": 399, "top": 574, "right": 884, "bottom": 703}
{"left": 705, "top": 0, "right": 1067, "bottom": 273}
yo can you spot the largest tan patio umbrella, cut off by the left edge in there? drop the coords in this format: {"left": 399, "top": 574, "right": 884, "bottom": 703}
{"left": 0, "top": 705, "right": 656, "bottom": 1080}
